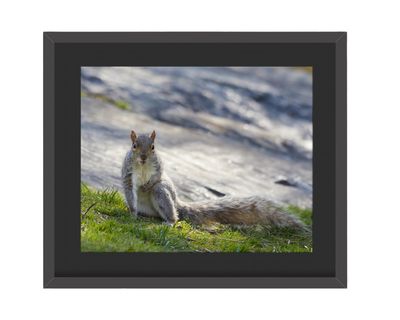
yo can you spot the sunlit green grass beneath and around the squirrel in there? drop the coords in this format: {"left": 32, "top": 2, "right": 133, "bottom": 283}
{"left": 81, "top": 184, "right": 312, "bottom": 252}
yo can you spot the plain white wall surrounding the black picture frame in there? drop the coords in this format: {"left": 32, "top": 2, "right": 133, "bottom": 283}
{"left": 0, "top": 0, "right": 400, "bottom": 319}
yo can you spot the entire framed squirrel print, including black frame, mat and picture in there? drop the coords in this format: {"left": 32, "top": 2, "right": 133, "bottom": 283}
{"left": 44, "top": 32, "right": 347, "bottom": 288}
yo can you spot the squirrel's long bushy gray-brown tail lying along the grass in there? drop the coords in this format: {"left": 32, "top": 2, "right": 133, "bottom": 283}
{"left": 177, "top": 197, "right": 306, "bottom": 229}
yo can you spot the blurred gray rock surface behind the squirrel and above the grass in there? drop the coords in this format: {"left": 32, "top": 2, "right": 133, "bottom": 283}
{"left": 81, "top": 67, "right": 312, "bottom": 208}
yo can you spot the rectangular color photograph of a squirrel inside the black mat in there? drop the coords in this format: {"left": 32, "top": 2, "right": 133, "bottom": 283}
{"left": 80, "top": 66, "right": 313, "bottom": 254}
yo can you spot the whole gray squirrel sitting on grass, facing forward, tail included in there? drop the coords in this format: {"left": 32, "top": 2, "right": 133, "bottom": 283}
{"left": 122, "top": 130, "right": 306, "bottom": 229}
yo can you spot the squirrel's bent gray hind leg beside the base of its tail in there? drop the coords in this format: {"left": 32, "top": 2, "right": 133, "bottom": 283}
{"left": 151, "top": 183, "right": 178, "bottom": 224}
